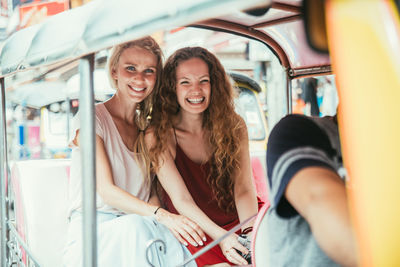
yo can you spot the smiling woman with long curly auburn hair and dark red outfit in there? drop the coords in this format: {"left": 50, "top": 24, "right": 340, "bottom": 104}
{"left": 146, "top": 47, "right": 262, "bottom": 266}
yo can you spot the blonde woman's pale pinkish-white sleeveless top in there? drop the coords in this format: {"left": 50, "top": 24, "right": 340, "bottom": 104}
{"left": 68, "top": 103, "right": 150, "bottom": 218}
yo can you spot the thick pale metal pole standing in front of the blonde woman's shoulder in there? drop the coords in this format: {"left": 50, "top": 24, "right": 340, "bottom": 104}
{"left": 79, "top": 54, "right": 97, "bottom": 267}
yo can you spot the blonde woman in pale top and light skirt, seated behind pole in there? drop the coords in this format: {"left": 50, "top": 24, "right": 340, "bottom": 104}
{"left": 64, "top": 37, "right": 200, "bottom": 267}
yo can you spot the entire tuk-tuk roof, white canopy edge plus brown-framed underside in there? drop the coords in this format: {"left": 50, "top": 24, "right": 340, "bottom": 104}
{"left": 0, "top": 0, "right": 330, "bottom": 77}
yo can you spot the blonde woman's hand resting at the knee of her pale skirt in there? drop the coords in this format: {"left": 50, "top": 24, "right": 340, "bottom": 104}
{"left": 156, "top": 209, "right": 207, "bottom": 247}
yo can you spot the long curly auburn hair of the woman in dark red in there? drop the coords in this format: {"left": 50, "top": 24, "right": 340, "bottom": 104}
{"left": 149, "top": 47, "right": 241, "bottom": 212}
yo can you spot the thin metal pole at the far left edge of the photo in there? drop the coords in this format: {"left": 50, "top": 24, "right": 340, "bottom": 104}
{"left": 0, "top": 78, "right": 8, "bottom": 267}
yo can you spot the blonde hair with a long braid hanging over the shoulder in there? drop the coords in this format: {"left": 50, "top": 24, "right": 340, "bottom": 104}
{"left": 107, "top": 36, "right": 163, "bottom": 184}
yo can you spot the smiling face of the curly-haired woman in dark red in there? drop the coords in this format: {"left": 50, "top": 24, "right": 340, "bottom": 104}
{"left": 176, "top": 58, "right": 211, "bottom": 114}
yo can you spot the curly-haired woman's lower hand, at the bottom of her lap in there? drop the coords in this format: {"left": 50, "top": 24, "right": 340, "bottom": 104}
{"left": 219, "top": 234, "right": 249, "bottom": 265}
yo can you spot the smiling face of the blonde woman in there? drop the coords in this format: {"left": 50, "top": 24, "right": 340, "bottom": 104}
{"left": 112, "top": 46, "right": 157, "bottom": 103}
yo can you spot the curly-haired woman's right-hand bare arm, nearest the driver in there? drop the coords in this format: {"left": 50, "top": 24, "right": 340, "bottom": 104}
{"left": 234, "top": 121, "right": 258, "bottom": 230}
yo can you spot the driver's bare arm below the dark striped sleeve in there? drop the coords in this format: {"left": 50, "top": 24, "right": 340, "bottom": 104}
{"left": 285, "top": 167, "right": 357, "bottom": 266}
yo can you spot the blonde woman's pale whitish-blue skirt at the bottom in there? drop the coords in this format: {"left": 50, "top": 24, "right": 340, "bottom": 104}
{"left": 63, "top": 212, "right": 197, "bottom": 267}
